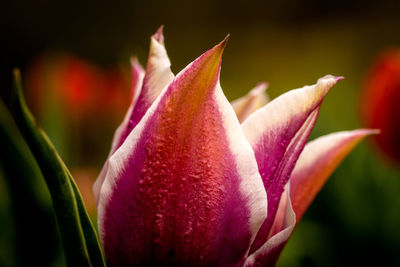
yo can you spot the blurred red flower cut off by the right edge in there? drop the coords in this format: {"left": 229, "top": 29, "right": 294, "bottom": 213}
{"left": 361, "top": 49, "right": 400, "bottom": 164}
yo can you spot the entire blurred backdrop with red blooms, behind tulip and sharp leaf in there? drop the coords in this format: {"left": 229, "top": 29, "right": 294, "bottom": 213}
{"left": 0, "top": 0, "right": 400, "bottom": 266}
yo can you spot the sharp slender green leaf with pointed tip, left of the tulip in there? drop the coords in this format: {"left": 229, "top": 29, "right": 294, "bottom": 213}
{"left": 12, "top": 70, "right": 105, "bottom": 266}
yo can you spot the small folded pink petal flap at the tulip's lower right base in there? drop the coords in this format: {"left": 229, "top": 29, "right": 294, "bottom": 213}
{"left": 244, "top": 184, "right": 296, "bottom": 267}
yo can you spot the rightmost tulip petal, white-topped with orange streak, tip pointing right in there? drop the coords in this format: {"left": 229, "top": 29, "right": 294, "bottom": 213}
{"left": 245, "top": 129, "right": 377, "bottom": 266}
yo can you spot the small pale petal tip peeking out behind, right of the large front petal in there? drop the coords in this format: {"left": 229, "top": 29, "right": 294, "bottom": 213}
{"left": 231, "top": 82, "right": 269, "bottom": 123}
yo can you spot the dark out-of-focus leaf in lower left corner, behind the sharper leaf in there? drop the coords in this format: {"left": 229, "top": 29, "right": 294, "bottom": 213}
{"left": 0, "top": 100, "right": 63, "bottom": 266}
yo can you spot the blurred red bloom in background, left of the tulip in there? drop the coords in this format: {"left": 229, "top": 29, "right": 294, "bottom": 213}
{"left": 26, "top": 54, "right": 130, "bottom": 120}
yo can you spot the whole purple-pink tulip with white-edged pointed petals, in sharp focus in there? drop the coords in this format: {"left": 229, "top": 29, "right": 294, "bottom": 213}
{"left": 94, "top": 29, "right": 373, "bottom": 266}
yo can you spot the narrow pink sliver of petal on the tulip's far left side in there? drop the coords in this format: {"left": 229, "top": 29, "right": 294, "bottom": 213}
{"left": 93, "top": 57, "right": 144, "bottom": 203}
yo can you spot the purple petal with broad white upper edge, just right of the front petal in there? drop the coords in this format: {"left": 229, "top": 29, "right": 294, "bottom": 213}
{"left": 242, "top": 76, "right": 341, "bottom": 253}
